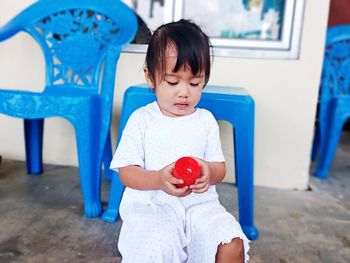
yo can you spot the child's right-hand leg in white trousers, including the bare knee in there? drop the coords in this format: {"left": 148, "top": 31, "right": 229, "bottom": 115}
{"left": 186, "top": 202, "right": 249, "bottom": 263}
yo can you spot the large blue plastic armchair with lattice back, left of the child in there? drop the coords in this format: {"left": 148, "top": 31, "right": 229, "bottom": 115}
{"left": 0, "top": 0, "right": 137, "bottom": 217}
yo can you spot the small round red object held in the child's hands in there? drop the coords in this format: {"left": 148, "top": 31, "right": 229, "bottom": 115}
{"left": 173, "top": 157, "right": 200, "bottom": 188}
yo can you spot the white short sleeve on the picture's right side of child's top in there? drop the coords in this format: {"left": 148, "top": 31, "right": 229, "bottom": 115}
{"left": 204, "top": 112, "right": 225, "bottom": 162}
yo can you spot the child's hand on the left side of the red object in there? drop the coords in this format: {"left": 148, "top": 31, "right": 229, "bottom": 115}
{"left": 158, "top": 162, "right": 192, "bottom": 197}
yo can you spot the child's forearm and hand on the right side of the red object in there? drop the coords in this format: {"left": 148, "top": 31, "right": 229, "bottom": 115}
{"left": 190, "top": 158, "right": 226, "bottom": 193}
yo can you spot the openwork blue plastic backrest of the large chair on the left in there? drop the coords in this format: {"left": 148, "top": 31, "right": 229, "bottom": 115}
{"left": 0, "top": 0, "right": 137, "bottom": 93}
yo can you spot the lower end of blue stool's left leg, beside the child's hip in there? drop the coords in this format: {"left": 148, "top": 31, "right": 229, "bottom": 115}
{"left": 102, "top": 172, "right": 124, "bottom": 223}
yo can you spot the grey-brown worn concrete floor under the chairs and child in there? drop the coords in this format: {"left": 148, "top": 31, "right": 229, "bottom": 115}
{"left": 0, "top": 134, "right": 350, "bottom": 263}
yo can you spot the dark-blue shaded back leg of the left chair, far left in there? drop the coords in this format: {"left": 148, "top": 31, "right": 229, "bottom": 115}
{"left": 24, "top": 119, "right": 44, "bottom": 174}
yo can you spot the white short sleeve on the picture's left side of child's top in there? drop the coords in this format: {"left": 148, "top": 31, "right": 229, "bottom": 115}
{"left": 110, "top": 110, "right": 145, "bottom": 171}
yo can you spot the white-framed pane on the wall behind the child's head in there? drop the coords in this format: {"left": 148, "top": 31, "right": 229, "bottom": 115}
{"left": 124, "top": 0, "right": 304, "bottom": 59}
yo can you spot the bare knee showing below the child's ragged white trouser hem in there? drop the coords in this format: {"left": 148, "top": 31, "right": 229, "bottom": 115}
{"left": 215, "top": 237, "right": 244, "bottom": 263}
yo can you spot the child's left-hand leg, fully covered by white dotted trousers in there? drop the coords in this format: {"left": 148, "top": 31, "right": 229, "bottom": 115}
{"left": 118, "top": 205, "right": 187, "bottom": 263}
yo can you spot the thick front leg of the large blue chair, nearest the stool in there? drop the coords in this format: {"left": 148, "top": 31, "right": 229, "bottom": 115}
{"left": 75, "top": 122, "right": 102, "bottom": 217}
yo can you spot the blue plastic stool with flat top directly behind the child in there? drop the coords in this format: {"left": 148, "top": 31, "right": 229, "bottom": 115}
{"left": 102, "top": 85, "right": 259, "bottom": 240}
